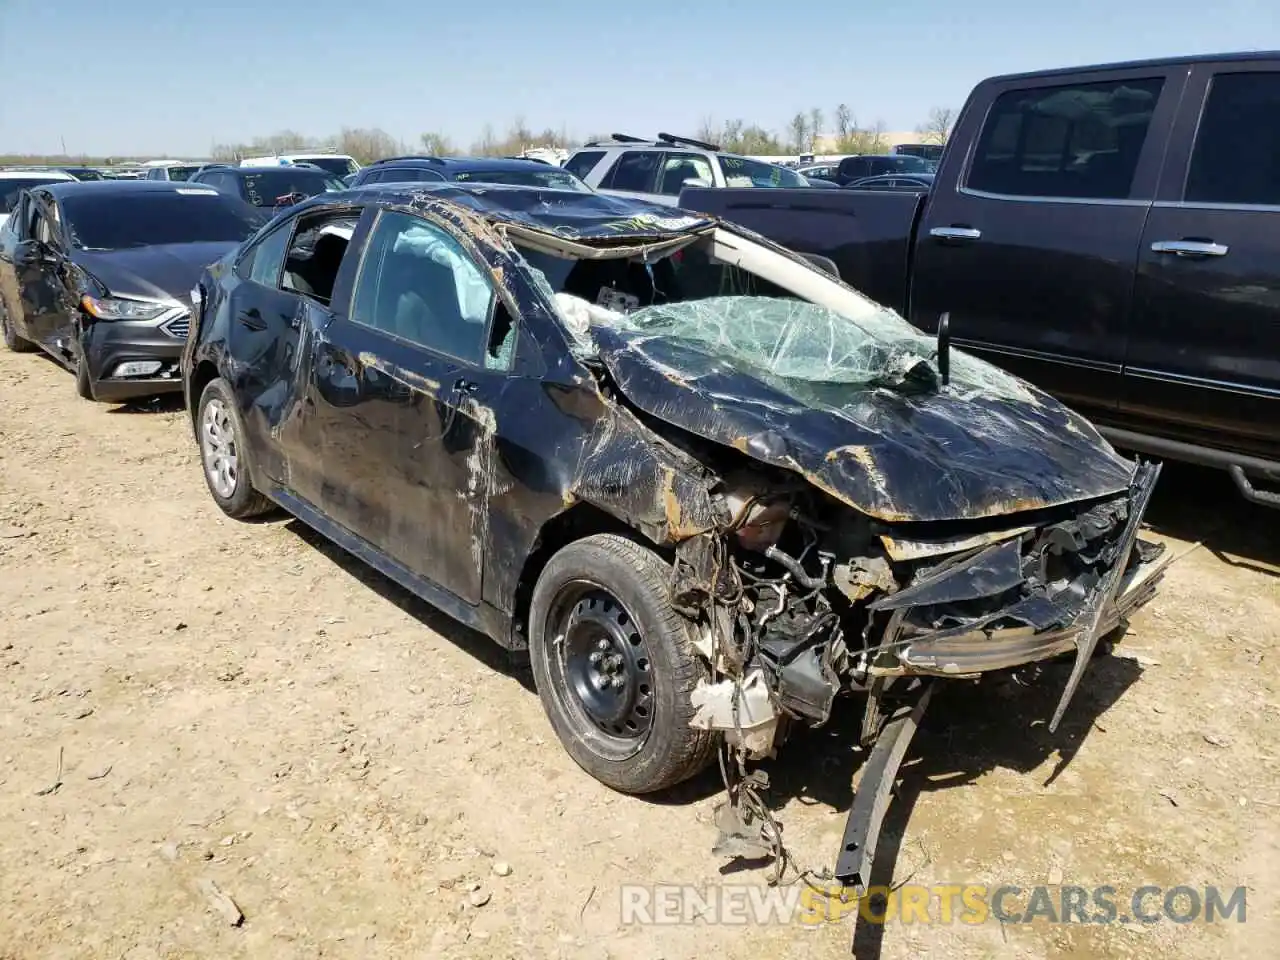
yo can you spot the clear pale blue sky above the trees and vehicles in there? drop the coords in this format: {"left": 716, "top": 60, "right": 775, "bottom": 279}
{"left": 0, "top": 0, "right": 1280, "bottom": 156}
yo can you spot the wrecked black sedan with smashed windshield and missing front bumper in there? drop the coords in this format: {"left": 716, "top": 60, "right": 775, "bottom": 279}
{"left": 183, "top": 184, "right": 1161, "bottom": 885}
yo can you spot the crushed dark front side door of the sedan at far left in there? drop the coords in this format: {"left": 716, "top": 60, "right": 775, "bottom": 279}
{"left": 13, "top": 193, "right": 76, "bottom": 356}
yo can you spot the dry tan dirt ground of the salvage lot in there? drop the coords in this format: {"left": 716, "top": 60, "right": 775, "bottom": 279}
{"left": 0, "top": 352, "right": 1280, "bottom": 960}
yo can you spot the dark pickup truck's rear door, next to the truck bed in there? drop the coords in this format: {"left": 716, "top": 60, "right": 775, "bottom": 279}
{"left": 910, "top": 67, "right": 1187, "bottom": 420}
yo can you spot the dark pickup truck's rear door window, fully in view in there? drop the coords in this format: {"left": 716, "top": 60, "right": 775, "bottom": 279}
{"left": 965, "top": 77, "right": 1165, "bottom": 200}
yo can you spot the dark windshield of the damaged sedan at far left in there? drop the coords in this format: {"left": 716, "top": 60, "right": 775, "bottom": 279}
{"left": 61, "top": 187, "right": 268, "bottom": 250}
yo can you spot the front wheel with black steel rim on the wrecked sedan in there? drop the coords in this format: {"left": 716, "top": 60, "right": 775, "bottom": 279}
{"left": 529, "top": 534, "right": 717, "bottom": 794}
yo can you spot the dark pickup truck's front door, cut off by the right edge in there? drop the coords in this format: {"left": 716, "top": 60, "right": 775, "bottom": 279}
{"left": 1123, "top": 60, "right": 1280, "bottom": 460}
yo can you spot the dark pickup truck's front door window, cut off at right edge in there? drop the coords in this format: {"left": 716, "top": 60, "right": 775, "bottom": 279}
{"left": 1184, "top": 73, "right": 1280, "bottom": 206}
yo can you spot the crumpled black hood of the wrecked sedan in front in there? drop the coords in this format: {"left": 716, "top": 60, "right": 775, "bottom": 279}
{"left": 591, "top": 326, "right": 1134, "bottom": 522}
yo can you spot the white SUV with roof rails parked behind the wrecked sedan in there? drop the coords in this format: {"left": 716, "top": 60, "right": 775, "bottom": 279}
{"left": 564, "top": 133, "right": 810, "bottom": 206}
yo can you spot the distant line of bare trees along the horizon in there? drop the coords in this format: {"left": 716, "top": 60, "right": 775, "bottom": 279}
{"left": 0, "top": 110, "right": 956, "bottom": 165}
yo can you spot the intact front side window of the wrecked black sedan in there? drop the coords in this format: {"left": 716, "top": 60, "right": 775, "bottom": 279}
{"left": 351, "top": 211, "right": 516, "bottom": 370}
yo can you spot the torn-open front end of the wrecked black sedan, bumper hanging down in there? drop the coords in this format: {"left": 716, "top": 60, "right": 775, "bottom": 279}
{"left": 673, "top": 463, "right": 1164, "bottom": 887}
